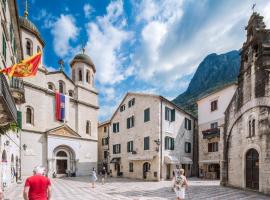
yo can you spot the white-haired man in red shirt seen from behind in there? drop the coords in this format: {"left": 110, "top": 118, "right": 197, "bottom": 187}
{"left": 23, "top": 167, "right": 51, "bottom": 200}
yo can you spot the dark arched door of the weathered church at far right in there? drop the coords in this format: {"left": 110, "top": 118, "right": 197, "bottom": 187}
{"left": 246, "top": 149, "right": 259, "bottom": 190}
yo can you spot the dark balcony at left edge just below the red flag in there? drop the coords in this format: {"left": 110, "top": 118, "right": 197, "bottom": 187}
{"left": 0, "top": 74, "right": 17, "bottom": 125}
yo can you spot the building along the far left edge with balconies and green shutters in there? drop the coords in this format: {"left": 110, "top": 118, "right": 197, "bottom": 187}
{"left": 0, "top": 0, "right": 23, "bottom": 189}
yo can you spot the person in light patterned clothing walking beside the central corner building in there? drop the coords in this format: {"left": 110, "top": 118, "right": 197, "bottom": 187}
{"left": 174, "top": 169, "right": 188, "bottom": 200}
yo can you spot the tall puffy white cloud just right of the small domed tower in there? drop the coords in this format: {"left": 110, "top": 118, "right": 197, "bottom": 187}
{"left": 86, "top": 0, "right": 132, "bottom": 85}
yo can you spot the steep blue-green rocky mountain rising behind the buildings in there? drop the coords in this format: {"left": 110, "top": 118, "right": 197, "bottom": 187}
{"left": 173, "top": 51, "right": 240, "bottom": 116}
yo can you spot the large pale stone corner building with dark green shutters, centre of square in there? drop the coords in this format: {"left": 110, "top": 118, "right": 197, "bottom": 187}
{"left": 109, "top": 93, "right": 196, "bottom": 180}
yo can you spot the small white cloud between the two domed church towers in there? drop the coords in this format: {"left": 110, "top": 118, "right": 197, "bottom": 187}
{"left": 51, "top": 14, "right": 79, "bottom": 58}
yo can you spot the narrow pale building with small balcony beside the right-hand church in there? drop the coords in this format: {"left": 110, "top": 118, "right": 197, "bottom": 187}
{"left": 197, "top": 83, "right": 237, "bottom": 179}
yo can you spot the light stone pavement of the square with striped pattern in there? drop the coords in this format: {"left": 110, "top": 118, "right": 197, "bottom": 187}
{"left": 2, "top": 177, "right": 270, "bottom": 200}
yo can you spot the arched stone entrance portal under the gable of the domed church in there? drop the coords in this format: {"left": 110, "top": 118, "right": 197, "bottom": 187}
{"left": 53, "top": 146, "right": 76, "bottom": 176}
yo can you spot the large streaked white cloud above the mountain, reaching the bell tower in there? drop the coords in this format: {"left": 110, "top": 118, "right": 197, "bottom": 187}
{"left": 132, "top": 0, "right": 270, "bottom": 91}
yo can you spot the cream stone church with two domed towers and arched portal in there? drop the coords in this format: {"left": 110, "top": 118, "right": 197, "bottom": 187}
{"left": 18, "top": 11, "right": 99, "bottom": 176}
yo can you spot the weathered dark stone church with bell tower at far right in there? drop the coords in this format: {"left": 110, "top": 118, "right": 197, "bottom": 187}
{"left": 222, "top": 13, "right": 270, "bottom": 194}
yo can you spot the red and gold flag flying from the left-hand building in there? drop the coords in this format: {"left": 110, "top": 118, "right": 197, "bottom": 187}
{"left": 0, "top": 52, "right": 41, "bottom": 77}
